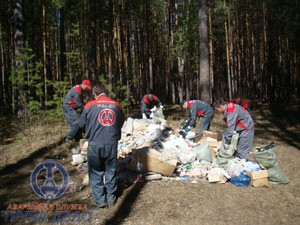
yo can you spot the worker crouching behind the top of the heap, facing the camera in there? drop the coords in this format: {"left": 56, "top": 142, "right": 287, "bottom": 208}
{"left": 141, "top": 94, "right": 163, "bottom": 119}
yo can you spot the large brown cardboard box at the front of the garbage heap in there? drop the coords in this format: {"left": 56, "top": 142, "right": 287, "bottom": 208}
{"left": 129, "top": 147, "right": 177, "bottom": 176}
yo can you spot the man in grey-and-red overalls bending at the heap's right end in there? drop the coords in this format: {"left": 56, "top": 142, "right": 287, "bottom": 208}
{"left": 213, "top": 101, "right": 254, "bottom": 160}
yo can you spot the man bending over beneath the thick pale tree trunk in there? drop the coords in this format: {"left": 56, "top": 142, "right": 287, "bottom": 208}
{"left": 180, "top": 100, "right": 214, "bottom": 139}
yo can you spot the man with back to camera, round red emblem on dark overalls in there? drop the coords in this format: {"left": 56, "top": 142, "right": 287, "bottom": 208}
{"left": 79, "top": 85, "right": 125, "bottom": 208}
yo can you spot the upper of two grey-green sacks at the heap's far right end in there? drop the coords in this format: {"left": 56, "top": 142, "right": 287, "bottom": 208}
{"left": 254, "top": 142, "right": 278, "bottom": 169}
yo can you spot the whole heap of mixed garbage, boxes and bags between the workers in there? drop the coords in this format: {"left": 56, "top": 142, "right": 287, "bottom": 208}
{"left": 72, "top": 117, "right": 289, "bottom": 187}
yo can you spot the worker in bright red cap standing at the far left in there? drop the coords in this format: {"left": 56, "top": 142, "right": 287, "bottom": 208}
{"left": 63, "top": 80, "right": 92, "bottom": 142}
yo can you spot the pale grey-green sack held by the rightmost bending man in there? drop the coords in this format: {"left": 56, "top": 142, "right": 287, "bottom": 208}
{"left": 216, "top": 132, "right": 239, "bottom": 166}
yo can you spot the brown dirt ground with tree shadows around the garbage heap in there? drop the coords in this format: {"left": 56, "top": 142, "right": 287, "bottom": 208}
{"left": 0, "top": 106, "right": 300, "bottom": 225}
